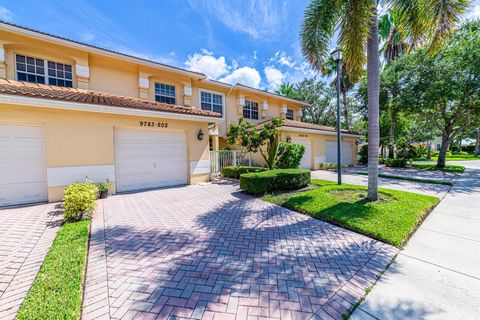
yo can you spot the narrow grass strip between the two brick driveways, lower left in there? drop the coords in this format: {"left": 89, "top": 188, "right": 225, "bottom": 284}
{"left": 17, "top": 220, "right": 90, "bottom": 320}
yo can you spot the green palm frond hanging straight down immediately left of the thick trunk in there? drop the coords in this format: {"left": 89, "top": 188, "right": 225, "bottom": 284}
{"left": 339, "top": 0, "right": 372, "bottom": 83}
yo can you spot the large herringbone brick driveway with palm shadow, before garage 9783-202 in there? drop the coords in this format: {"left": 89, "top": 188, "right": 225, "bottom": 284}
{"left": 83, "top": 182, "right": 397, "bottom": 320}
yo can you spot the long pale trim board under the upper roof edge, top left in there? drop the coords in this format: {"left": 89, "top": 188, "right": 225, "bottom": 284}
{"left": 0, "top": 22, "right": 207, "bottom": 79}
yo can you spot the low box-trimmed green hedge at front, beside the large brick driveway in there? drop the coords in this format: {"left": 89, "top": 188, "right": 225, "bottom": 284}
{"left": 240, "top": 169, "right": 310, "bottom": 194}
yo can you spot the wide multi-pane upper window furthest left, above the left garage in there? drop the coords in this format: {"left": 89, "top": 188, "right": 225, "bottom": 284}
{"left": 15, "top": 54, "right": 73, "bottom": 88}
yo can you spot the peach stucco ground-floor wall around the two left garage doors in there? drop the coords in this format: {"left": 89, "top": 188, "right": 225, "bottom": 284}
{"left": 0, "top": 104, "right": 210, "bottom": 201}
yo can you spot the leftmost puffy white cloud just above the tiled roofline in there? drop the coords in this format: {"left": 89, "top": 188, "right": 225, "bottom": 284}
{"left": 185, "top": 49, "right": 229, "bottom": 79}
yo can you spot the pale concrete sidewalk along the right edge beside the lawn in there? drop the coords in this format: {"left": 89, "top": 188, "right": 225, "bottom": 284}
{"left": 350, "top": 166, "right": 480, "bottom": 320}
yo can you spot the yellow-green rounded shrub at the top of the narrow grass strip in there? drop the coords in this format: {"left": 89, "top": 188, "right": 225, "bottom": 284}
{"left": 63, "top": 182, "right": 99, "bottom": 220}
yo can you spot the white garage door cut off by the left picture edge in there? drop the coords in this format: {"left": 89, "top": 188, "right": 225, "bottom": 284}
{"left": 0, "top": 124, "right": 48, "bottom": 206}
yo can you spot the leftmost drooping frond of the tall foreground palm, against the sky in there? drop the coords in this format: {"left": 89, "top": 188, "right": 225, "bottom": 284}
{"left": 300, "top": 0, "right": 342, "bottom": 70}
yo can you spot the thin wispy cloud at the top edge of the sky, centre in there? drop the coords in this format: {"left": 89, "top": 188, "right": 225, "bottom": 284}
{"left": 190, "top": 0, "right": 288, "bottom": 39}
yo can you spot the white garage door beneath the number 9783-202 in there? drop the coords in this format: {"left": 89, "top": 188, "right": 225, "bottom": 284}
{"left": 115, "top": 129, "right": 187, "bottom": 192}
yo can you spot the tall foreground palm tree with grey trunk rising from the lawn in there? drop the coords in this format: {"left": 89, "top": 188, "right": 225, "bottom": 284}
{"left": 300, "top": 0, "right": 470, "bottom": 201}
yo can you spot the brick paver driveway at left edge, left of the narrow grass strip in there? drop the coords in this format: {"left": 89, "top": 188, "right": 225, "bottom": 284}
{"left": 0, "top": 204, "right": 63, "bottom": 320}
